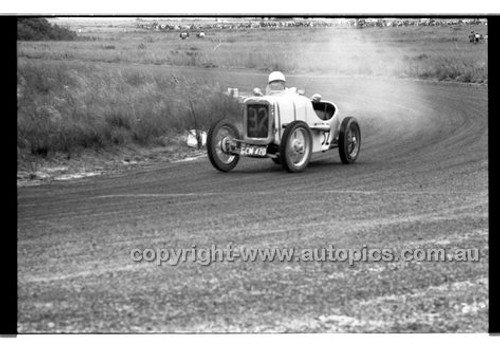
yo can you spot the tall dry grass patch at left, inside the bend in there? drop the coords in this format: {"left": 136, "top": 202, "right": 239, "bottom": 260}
{"left": 18, "top": 59, "right": 239, "bottom": 157}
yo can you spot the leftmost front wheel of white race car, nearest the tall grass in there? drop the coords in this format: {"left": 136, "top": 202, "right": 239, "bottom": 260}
{"left": 207, "top": 120, "right": 240, "bottom": 172}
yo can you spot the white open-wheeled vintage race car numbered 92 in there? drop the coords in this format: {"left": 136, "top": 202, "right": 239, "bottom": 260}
{"left": 207, "top": 91, "right": 361, "bottom": 172}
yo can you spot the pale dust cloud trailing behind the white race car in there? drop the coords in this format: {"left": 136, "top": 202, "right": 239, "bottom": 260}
{"left": 290, "top": 29, "right": 433, "bottom": 146}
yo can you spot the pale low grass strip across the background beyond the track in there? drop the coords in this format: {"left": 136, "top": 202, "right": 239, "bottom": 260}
{"left": 19, "top": 26, "right": 488, "bottom": 83}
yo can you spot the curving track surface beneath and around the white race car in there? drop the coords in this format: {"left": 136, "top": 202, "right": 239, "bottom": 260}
{"left": 18, "top": 73, "right": 488, "bottom": 332}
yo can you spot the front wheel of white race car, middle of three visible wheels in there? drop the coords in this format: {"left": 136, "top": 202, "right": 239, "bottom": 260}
{"left": 280, "top": 121, "right": 312, "bottom": 172}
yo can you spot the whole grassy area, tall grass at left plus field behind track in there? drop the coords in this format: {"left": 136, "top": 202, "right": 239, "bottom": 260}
{"left": 18, "top": 19, "right": 488, "bottom": 166}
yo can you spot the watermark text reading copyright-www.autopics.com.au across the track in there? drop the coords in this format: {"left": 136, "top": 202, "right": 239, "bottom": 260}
{"left": 130, "top": 244, "right": 481, "bottom": 266}
